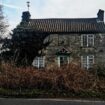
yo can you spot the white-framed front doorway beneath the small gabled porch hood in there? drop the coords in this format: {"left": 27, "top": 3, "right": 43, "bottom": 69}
{"left": 58, "top": 56, "right": 69, "bottom": 67}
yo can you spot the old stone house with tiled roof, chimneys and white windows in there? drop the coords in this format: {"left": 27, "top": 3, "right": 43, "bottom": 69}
{"left": 19, "top": 9, "right": 105, "bottom": 69}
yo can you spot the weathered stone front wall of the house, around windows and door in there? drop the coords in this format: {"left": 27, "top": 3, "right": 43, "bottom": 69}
{"left": 46, "top": 34, "right": 105, "bottom": 66}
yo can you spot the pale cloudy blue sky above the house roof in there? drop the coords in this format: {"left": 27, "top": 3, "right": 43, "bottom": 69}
{"left": 0, "top": 0, "right": 105, "bottom": 30}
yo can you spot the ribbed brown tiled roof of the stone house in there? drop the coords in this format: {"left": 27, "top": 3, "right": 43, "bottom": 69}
{"left": 19, "top": 18, "right": 105, "bottom": 33}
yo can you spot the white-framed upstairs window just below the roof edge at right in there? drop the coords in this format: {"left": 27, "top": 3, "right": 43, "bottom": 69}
{"left": 81, "top": 34, "right": 94, "bottom": 47}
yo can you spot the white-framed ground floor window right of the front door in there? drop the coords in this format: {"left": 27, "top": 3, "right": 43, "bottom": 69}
{"left": 81, "top": 55, "right": 94, "bottom": 69}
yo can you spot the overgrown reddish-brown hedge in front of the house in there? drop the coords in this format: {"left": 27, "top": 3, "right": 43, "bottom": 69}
{"left": 0, "top": 63, "right": 95, "bottom": 92}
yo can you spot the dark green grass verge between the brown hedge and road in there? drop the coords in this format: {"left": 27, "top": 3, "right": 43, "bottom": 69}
{"left": 0, "top": 88, "right": 105, "bottom": 100}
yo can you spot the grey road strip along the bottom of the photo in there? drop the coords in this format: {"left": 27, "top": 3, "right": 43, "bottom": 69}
{"left": 0, "top": 98, "right": 105, "bottom": 105}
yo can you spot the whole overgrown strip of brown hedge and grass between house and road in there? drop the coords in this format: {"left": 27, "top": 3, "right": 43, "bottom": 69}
{"left": 0, "top": 63, "right": 105, "bottom": 99}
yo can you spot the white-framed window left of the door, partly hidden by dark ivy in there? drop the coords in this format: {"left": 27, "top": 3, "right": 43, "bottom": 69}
{"left": 32, "top": 56, "right": 45, "bottom": 68}
